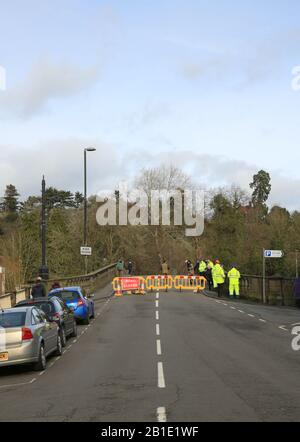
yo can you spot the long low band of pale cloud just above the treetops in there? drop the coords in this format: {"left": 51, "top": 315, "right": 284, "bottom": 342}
{"left": 0, "top": 142, "right": 300, "bottom": 210}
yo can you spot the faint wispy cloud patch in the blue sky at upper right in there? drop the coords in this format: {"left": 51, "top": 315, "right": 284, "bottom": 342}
{"left": 180, "top": 28, "right": 300, "bottom": 90}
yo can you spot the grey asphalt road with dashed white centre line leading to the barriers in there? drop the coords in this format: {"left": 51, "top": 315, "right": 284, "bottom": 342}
{"left": 0, "top": 287, "right": 300, "bottom": 422}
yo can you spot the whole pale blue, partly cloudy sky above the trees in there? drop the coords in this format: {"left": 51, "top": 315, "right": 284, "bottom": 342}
{"left": 0, "top": 0, "right": 300, "bottom": 210}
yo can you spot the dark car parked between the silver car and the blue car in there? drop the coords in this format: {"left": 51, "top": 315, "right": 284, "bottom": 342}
{"left": 15, "top": 296, "right": 77, "bottom": 347}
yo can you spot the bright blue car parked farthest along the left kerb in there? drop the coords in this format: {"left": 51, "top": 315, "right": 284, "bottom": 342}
{"left": 49, "top": 287, "right": 95, "bottom": 324}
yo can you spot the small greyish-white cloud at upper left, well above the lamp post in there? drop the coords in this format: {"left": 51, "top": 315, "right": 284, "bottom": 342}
{"left": 0, "top": 59, "right": 99, "bottom": 118}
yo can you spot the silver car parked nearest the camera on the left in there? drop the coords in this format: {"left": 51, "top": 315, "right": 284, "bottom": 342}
{"left": 0, "top": 307, "right": 62, "bottom": 370}
